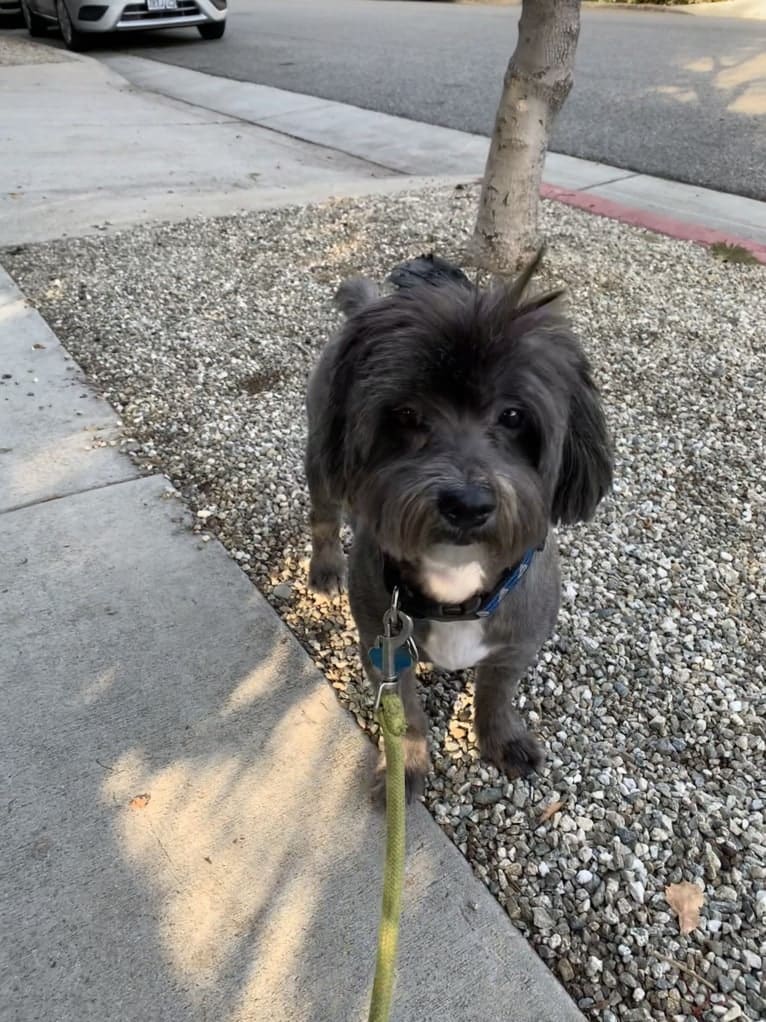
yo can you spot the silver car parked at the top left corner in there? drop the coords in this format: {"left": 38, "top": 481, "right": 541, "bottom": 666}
{"left": 20, "top": 0, "right": 227, "bottom": 50}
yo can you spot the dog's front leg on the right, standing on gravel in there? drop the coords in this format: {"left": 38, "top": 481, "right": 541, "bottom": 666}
{"left": 474, "top": 663, "right": 545, "bottom": 778}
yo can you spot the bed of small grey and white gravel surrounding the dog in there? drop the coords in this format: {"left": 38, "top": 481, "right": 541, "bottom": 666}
{"left": 2, "top": 188, "right": 766, "bottom": 1022}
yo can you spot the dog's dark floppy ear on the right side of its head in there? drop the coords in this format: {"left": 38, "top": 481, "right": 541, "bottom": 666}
{"left": 550, "top": 357, "right": 613, "bottom": 525}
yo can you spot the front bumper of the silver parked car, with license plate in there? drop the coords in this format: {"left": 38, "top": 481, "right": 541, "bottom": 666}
{"left": 67, "top": 0, "right": 227, "bottom": 32}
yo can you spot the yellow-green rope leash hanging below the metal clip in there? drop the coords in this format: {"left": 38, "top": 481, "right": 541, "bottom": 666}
{"left": 369, "top": 692, "right": 406, "bottom": 1022}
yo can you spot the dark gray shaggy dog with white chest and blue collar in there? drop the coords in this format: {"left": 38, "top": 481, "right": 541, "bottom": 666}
{"left": 305, "top": 257, "right": 612, "bottom": 797}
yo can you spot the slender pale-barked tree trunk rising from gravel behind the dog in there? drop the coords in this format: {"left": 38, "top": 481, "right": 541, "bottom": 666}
{"left": 471, "top": 0, "right": 580, "bottom": 276}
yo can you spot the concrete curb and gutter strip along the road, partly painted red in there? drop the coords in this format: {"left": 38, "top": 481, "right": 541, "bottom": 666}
{"left": 108, "top": 56, "right": 766, "bottom": 261}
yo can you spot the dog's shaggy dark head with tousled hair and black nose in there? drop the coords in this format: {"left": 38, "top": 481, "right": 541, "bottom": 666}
{"left": 320, "top": 261, "right": 612, "bottom": 563}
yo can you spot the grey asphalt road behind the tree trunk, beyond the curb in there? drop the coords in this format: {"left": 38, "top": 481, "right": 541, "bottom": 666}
{"left": 18, "top": 0, "right": 766, "bottom": 199}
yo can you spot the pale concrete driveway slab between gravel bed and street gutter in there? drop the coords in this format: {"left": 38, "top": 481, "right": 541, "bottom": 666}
{"left": 0, "top": 34, "right": 390, "bottom": 245}
